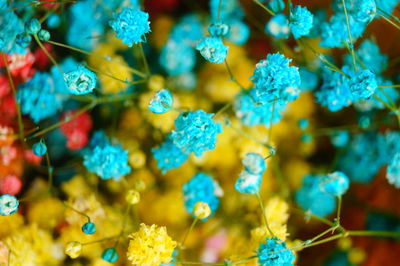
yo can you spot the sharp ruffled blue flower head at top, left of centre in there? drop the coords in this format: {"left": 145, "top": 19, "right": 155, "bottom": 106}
{"left": 110, "top": 7, "right": 150, "bottom": 47}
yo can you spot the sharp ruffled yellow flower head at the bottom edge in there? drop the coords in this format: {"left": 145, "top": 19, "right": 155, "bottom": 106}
{"left": 127, "top": 224, "right": 176, "bottom": 266}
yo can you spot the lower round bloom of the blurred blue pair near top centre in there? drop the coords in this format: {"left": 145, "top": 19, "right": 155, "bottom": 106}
{"left": 159, "top": 40, "right": 196, "bottom": 75}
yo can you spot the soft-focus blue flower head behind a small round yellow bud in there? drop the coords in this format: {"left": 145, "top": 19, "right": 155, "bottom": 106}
{"left": 183, "top": 173, "right": 221, "bottom": 217}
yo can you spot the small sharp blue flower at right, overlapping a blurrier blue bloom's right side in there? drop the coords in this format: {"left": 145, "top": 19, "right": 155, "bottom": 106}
{"left": 349, "top": 69, "right": 378, "bottom": 100}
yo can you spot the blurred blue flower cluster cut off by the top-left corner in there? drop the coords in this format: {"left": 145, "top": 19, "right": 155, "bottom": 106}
{"left": 0, "top": 1, "right": 25, "bottom": 54}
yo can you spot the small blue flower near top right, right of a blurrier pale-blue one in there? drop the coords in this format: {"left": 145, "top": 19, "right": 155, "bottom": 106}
{"left": 289, "top": 6, "right": 313, "bottom": 39}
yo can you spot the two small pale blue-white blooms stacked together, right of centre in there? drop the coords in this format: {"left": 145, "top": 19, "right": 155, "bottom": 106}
{"left": 235, "top": 152, "right": 266, "bottom": 194}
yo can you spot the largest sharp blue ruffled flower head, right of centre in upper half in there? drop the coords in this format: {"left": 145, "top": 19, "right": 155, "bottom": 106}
{"left": 251, "top": 53, "right": 300, "bottom": 103}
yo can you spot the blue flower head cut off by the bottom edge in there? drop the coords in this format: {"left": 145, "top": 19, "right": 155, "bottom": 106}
{"left": 257, "top": 237, "right": 296, "bottom": 266}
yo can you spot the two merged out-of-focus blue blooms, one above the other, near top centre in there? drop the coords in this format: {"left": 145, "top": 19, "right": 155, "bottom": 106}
{"left": 159, "top": 15, "right": 202, "bottom": 76}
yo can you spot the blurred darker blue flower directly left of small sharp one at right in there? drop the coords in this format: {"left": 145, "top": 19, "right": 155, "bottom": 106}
{"left": 315, "top": 70, "right": 352, "bottom": 112}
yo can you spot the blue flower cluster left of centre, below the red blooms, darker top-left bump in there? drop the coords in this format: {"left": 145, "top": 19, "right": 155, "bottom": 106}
{"left": 83, "top": 132, "right": 131, "bottom": 180}
